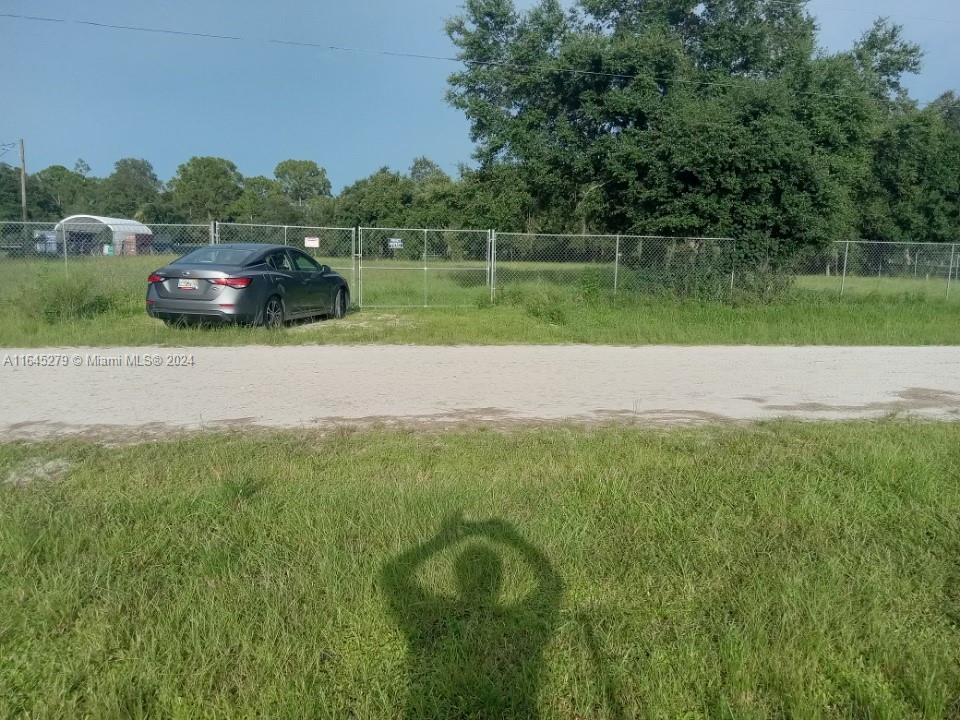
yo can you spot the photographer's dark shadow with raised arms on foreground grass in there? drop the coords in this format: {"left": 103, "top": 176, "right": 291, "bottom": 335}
{"left": 381, "top": 515, "right": 563, "bottom": 720}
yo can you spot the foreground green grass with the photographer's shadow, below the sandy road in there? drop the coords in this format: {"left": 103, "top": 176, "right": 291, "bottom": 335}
{"left": 0, "top": 421, "right": 960, "bottom": 719}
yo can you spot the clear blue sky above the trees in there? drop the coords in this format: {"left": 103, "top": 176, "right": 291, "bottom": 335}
{"left": 0, "top": 0, "right": 960, "bottom": 189}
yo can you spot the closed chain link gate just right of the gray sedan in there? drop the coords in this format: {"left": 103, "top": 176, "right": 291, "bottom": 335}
{"left": 358, "top": 228, "right": 492, "bottom": 308}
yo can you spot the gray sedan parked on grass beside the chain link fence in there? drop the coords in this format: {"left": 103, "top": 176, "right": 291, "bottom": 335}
{"left": 147, "top": 244, "right": 350, "bottom": 327}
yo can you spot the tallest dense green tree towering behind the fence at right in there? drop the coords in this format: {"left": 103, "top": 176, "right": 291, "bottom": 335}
{"left": 448, "top": 0, "right": 952, "bottom": 261}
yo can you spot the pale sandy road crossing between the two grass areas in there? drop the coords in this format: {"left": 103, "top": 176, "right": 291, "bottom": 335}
{"left": 0, "top": 346, "right": 960, "bottom": 439}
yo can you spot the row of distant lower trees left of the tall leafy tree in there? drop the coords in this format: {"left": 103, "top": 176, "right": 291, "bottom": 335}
{"left": 0, "top": 157, "right": 521, "bottom": 228}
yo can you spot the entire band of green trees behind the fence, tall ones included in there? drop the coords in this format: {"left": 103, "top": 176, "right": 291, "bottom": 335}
{"left": 0, "top": 0, "right": 960, "bottom": 259}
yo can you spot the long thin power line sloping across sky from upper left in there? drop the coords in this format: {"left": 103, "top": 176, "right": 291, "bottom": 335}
{"left": 0, "top": 11, "right": 952, "bottom": 106}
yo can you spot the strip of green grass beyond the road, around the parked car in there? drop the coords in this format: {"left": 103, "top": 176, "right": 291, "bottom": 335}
{"left": 0, "top": 256, "right": 960, "bottom": 347}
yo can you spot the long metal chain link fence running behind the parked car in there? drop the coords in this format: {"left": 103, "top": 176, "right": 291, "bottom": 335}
{"left": 0, "top": 217, "right": 960, "bottom": 307}
